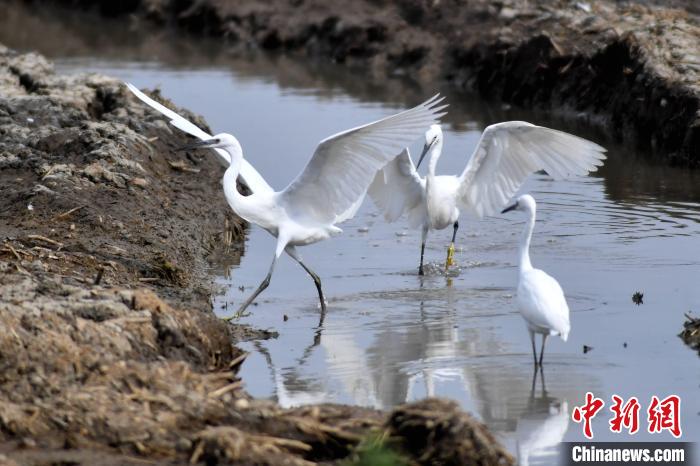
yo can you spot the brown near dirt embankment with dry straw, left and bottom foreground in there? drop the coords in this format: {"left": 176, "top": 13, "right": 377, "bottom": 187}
{"left": 0, "top": 46, "right": 513, "bottom": 465}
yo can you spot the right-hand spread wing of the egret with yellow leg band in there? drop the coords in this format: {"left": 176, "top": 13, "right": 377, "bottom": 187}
{"left": 458, "top": 121, "right": 605, "bottom": 218}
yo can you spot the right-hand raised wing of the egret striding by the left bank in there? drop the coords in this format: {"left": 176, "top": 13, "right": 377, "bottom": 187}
{"left": 280, "top": 95, "right": 445, "bottom": 224}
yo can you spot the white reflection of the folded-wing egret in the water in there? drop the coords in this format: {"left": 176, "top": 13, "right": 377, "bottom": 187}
{"left": 515, "top": 367, "right": 569, "bottom": 466}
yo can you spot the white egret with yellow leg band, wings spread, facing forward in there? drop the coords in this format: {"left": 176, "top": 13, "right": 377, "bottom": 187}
{"left": 368, "top": 121, "right": 605, "bottom": 275}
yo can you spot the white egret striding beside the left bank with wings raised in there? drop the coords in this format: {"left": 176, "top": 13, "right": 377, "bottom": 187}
{"left": 127, "top": 83, "right": 446, "bottom": 315}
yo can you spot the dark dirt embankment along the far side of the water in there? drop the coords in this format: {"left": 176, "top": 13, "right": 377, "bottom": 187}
{"left": 17, "top": 0, "right": 700, "bottom": 167}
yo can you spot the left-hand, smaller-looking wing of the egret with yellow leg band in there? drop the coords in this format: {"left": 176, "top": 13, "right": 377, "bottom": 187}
{"left": 367, "top": 149, "right": 425, "bottom": 222}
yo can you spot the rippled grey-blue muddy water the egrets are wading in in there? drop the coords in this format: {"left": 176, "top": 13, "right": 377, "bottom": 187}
{"left": 0, "top": 2, "right": 700, "bottom": 464}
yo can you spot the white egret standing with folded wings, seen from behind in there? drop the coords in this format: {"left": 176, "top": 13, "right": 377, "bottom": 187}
{"left": 502, "top": 194, "right": 571, "bottom": 367}
